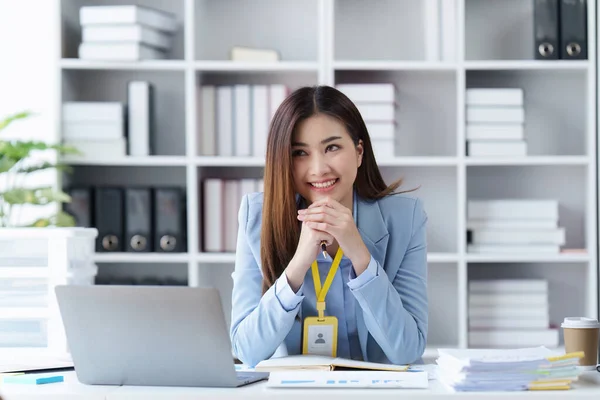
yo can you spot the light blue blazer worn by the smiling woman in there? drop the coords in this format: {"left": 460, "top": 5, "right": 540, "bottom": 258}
{"left": 230, "top": 193, "right": 428, "bottom": 366}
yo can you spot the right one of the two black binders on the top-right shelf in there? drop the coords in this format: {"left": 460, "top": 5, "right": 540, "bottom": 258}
{"left": 559, "top": 0, "right": 587, "bottom": 60}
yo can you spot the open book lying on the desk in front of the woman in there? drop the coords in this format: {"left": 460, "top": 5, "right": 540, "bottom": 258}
{"left": 254, "top": 354, "right": 408, "bottom": 372}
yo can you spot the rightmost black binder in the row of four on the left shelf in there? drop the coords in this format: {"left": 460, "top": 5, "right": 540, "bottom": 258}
{"left": 154, "top": 188, "right": 187, "bottom": 253}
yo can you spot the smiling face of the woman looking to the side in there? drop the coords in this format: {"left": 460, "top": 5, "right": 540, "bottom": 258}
{"left": 292, "top": 114, "right": 363, "bottom": 208}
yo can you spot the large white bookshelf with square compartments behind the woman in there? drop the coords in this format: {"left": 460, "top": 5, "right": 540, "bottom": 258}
{"left": 56, "top": 0, "right": 598, "bottom": 357}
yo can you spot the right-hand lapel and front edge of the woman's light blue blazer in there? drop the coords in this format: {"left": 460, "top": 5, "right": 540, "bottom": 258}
{"left": 354, "top": 194, "right": 390, "bottom": 360}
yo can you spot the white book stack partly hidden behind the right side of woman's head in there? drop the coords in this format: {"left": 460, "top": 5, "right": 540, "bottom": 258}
{"left": 336, "top": 83, "right": 396, "bottom": 160}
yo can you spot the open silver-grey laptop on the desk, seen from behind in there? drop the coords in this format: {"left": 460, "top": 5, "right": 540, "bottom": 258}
{"left": 55, "top": 285, "right": 269, "bottom": 387}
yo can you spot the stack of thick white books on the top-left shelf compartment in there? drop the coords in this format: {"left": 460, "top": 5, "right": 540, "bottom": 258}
{"left": 79, "top": 5, "right": 177, "bottom": 61}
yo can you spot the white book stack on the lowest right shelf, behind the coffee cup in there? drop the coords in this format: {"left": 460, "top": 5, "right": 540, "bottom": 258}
{"left": 469, "top": 279, "right": 559, "bottom": 348}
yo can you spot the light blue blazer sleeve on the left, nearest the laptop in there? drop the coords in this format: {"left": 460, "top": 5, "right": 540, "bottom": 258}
{"left": 229, "top": 195, "right": 301, "bottom": 367}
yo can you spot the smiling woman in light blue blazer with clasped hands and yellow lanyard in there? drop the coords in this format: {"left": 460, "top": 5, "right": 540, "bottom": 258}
{"left": 230, "top": 86, "right": 428, "bottom": 366}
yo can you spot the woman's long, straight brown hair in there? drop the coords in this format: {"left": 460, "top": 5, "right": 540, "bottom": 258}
{"left": 260, "top": 86, "right": 402, "bottom": 293}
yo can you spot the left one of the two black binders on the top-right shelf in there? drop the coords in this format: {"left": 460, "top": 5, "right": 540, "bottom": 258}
{"left": 533, "top": 0, "right": 560, "bottom": 60}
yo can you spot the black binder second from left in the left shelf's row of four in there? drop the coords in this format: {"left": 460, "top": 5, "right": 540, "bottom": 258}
{"left": 94, "top": 187, "right": 124, "bottom": 252}
